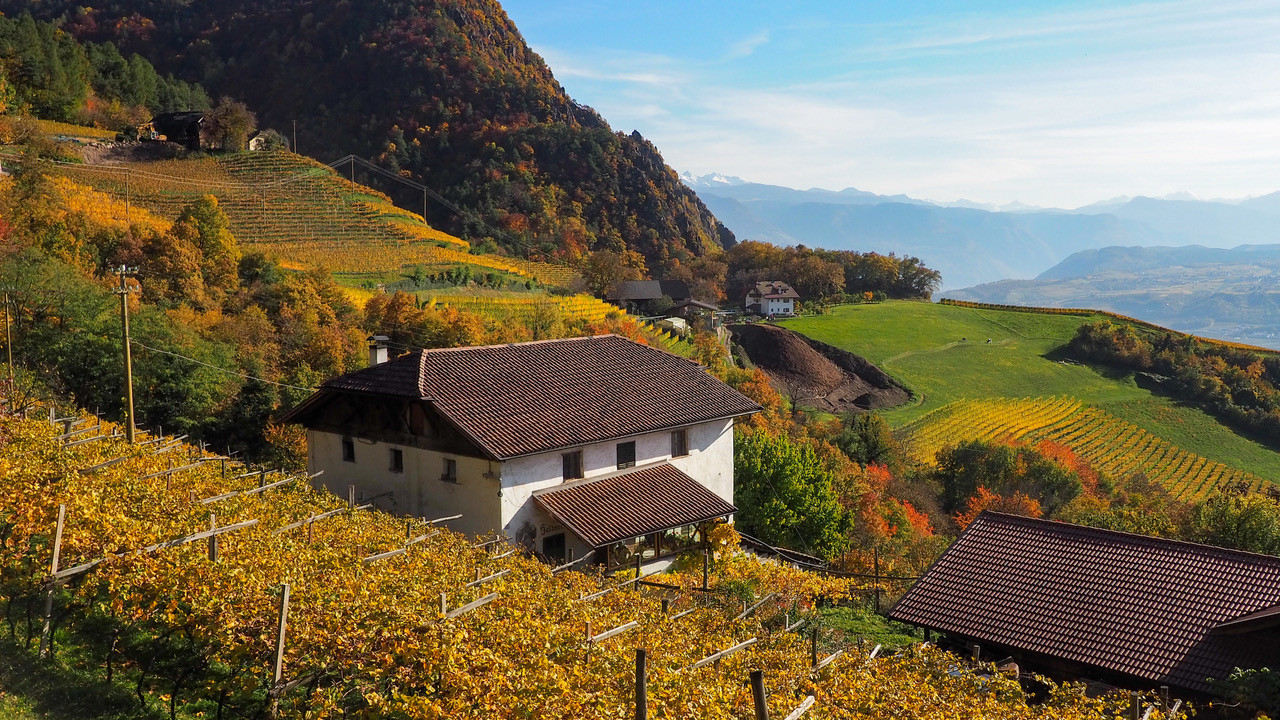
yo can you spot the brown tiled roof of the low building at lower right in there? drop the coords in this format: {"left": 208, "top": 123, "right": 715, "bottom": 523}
{"left": 890, "top": 512, "right": 1280, "bottom": 692}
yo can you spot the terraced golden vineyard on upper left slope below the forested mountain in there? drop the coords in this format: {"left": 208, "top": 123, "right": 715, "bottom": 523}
{"left": 49, "top": 151, "right": 575, "bottom": 286}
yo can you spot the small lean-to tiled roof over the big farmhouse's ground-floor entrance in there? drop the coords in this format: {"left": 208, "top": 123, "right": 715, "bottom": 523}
{"left": 534, "top": 462, "right": 737, "bottom": 547}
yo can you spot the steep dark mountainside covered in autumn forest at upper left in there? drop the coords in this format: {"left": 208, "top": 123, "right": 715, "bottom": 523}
{"left": 0, "top": 0, "right": 733, "bottom": 273}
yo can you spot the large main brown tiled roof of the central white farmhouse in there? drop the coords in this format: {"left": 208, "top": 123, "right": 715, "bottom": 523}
{"left": 311, "top": 336, "right": 760, "bottom": 460}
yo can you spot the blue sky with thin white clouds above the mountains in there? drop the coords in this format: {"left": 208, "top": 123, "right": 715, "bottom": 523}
{"left": 503, "top": 0, "right": 1280, "bottom": 208}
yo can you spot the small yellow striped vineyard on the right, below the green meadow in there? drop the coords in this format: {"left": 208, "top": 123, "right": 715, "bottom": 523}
{"left": 899, "top": 397, "right": 1266, "bottom": 500}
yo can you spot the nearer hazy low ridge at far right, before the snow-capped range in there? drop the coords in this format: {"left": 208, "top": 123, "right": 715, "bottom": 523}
{"left": 943, "top": 245, "right": 1280, "bottom": 348}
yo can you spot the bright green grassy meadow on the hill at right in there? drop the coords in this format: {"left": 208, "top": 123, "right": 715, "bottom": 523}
{"left": 783, "top": 301, "right": 1280, "bottom": 480}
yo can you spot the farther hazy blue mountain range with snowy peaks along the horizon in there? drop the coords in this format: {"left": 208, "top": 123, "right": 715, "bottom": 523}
{"left": 681, "top": 173, "right": 1280, "bottom": 288}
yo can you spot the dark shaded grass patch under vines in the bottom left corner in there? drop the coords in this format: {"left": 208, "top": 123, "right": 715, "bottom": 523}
{"left": 0, "top": 637, "right": 163, "bottom": 720}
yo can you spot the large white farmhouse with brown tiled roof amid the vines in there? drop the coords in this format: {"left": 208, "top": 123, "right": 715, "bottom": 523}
{"left": 287, "top": 336, "right": 760, "bottom": 566}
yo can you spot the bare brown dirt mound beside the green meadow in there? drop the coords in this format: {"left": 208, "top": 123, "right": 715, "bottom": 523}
{"left": 730, "top": 324, "right": 911, "bottom": 413}
